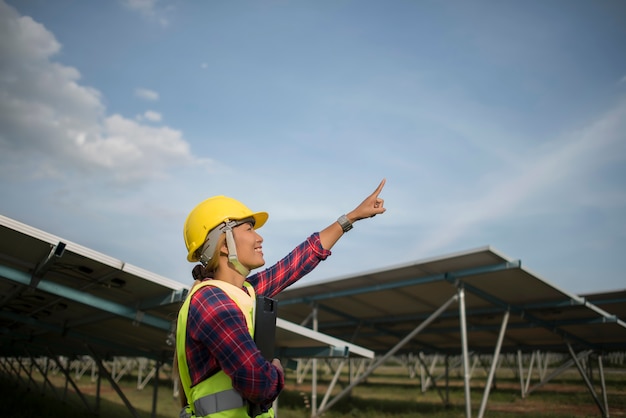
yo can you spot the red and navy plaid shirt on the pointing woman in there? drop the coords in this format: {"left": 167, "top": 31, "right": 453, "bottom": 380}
{"left": 185, "top": 233, "right": 331, "bottom": 405}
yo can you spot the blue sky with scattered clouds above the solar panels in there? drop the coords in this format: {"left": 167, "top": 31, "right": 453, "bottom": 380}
{"left": 0, "top": 0, "right": 626, "bottom": 294}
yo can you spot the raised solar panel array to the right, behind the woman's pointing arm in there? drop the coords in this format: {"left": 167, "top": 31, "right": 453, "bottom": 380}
{"left": 279, "top": 247, "right": 626, "bottom": 353}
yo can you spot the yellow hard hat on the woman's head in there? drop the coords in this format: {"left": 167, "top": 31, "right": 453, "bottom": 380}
{"left": 183, "top": 196, "right": 269, "bottom": 262}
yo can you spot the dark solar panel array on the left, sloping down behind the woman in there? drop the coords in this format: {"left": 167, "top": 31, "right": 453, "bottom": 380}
{"left": 0, "top": 215, "right": 373, "bottom": 363}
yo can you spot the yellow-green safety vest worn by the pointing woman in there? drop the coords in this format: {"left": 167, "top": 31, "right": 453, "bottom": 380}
{"left": 176, "top": 280, "right": 274, "bottom": 418}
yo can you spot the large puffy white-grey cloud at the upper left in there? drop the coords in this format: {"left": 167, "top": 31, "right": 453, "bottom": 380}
{"left": 0, "top": 2, "right": 194, "bottom": 183}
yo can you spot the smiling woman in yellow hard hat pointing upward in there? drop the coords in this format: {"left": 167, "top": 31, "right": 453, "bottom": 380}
{"left": 176, "top": 179, "right": 385, "bottom": 418}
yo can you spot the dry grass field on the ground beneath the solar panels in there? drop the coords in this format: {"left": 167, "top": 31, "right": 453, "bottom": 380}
{"left": 0, "top": 360, "right": 626, "bottom": 418}
